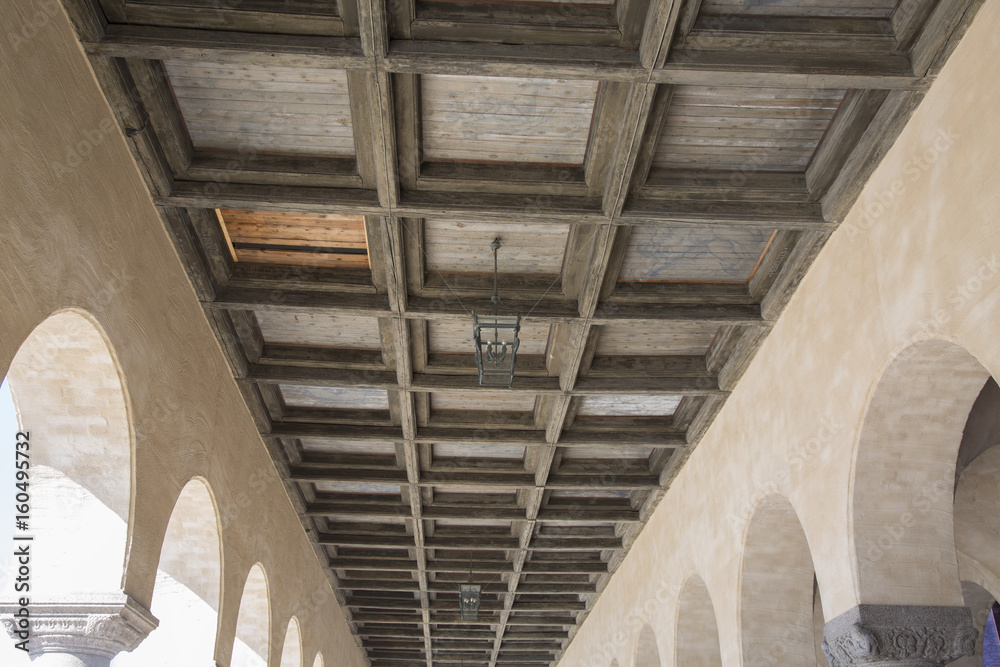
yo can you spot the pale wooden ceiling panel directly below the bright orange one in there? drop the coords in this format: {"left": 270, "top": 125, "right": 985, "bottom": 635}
{"left": 256, "top": 310, "right": 381, "bottom": 350}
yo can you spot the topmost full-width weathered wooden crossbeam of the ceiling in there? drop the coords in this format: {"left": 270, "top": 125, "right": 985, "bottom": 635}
{"left": 83, "top": 24, "right": 928, "bottom": 89}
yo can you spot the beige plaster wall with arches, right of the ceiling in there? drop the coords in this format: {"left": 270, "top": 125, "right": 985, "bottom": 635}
{"left": 560, "top": 0, "right": 1000, "bottom": 667}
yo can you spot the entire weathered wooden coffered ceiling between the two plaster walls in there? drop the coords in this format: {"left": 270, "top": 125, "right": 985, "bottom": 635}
{"left": 64, "top": 0, "right": 980, "bottom": 667}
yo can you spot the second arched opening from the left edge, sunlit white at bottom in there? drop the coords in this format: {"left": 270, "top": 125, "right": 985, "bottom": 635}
{"left": 115, "top": 479, "right": 222, "bottom": 667}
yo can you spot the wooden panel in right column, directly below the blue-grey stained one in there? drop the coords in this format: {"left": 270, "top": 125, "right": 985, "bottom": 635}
{"left": 594, "top": 323, "right": 719, "bottom": 357}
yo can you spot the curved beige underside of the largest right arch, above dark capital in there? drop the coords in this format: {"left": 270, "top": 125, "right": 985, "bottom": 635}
{"left": 850, "top": 340, "right": 989, "bottom": 605}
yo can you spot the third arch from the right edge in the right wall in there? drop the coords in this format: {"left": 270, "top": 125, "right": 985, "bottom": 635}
{"left": 674, "top": 574, "right": 722, "bottom": 667}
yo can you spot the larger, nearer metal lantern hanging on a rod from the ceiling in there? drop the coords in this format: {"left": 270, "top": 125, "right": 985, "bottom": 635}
{"left": 472, "top": 238, "right": 521, "bottom": 387}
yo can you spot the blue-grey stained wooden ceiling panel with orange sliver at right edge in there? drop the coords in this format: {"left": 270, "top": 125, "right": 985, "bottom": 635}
{"left": 618, "top": 227, "right": 774, "bottom": 283}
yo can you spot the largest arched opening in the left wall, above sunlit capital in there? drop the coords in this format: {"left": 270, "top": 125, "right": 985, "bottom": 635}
{"left": 6, "top": 310, "right": 134, "bottom": 599}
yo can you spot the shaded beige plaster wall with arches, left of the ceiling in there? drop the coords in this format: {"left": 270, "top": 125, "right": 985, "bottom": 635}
{"left": 0, "top": 0, "right": 362, "bottom": 666}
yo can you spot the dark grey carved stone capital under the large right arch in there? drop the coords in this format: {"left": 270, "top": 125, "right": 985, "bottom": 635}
{"left": 823, "top": 604, "right": 978, "bottom": 667}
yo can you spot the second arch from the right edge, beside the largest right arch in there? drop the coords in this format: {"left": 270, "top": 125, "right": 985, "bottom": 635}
{"left": 739, "top": 494, "right": 816, "bottom": 667}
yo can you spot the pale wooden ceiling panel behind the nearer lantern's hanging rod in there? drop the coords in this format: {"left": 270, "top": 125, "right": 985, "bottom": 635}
{"left": 423, "top": 219, "right": 570, "bottom": 276}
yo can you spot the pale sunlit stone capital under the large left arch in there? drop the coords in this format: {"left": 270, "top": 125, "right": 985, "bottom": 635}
{"left": 0, "top": 594, "right": 158, "bottom": 667}
